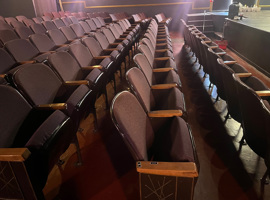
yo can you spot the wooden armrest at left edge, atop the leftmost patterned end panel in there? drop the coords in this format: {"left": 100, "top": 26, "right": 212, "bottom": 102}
{"left": 0, "top": 148, "right": 31, "bottom": 162}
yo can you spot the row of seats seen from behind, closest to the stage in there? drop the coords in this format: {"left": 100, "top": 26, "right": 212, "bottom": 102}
{"left": 181, "top": 20, "right": 270, "bottom": 182}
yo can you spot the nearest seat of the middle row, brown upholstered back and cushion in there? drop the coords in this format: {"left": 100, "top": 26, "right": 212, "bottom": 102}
{"left": 111, "top": 91, "right": 197, "bottom": 166}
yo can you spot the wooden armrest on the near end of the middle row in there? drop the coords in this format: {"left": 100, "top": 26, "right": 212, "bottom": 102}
{"left": 136, "top": 161, "right": 199, "bottom": 177}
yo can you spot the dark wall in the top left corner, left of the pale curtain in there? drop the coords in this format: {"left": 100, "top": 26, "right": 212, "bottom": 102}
{"left": 0, "top": 0, "right": 35, "bottom": 18}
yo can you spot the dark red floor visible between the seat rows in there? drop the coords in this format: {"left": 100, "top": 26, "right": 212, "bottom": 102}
{"left": 44, "top": 32, "right": 270, "bottom": 200}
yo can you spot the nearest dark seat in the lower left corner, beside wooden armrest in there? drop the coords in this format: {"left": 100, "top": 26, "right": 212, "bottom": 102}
{"left": 0, "top": 85, "right": 76, "bottom": 199}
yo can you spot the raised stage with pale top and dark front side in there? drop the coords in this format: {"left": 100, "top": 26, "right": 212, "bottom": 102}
{"left": 224, "top": 10, "right": 270, "bottom": 77}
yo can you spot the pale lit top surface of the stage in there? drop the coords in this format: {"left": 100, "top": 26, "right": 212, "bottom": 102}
{"left": 232, "top": 10, "right": 270, "bottom": 32}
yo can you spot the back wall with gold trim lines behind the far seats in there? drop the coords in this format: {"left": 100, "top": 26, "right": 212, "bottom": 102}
{"left": 60, "top": 0, "right": 210, "bottom": 30}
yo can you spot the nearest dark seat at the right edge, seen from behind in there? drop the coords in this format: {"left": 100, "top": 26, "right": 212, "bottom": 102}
{"left": 233, "top": 75, "right": 270, "bottom": 183}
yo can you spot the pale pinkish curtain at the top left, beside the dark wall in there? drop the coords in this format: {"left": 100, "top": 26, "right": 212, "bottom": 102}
{"left": 33, "top": 0, "right": 57, "bottom": 16}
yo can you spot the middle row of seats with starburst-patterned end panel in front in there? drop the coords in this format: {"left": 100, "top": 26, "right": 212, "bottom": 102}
{"left": 111, "top": 20, "right": 199, "bottom": 199}
